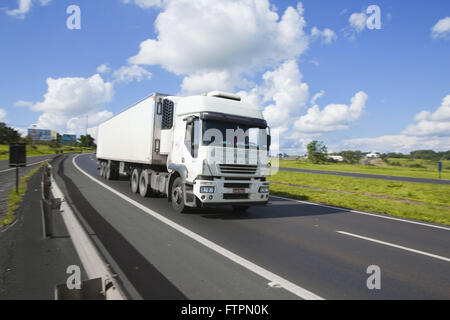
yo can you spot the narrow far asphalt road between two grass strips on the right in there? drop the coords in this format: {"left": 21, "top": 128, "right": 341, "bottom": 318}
{"left": 280, "top": 167, "right": 450, "bottom": 184}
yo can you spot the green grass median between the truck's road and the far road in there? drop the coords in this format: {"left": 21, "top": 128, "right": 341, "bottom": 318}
{"left": 270, "top": 171, "right": 450, "bottom": 225}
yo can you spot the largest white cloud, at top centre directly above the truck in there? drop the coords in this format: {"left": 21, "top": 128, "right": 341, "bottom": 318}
{"left": 129, "top": 0, "right": 308, "bottom": 91}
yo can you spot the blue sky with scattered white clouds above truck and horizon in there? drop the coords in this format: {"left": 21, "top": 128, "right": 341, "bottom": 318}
{"left": 0, "top": 0, "right": 450, "bottom": 154}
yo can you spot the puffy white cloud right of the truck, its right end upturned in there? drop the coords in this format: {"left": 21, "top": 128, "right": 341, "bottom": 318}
{"left": 294, "top": 91, "right": 368, "bottom": 135}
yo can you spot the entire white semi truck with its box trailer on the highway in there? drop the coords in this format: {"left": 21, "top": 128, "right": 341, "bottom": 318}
{"left": 97, "top": 91, "right": 270, "bottom": 212}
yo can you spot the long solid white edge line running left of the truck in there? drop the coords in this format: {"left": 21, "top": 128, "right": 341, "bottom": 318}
{"left": 72, "top": 155, "right": 323, "bottom": 300}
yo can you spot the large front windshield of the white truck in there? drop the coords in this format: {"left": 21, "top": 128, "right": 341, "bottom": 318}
{"left": 202, "top": 120, "right": 267, "bottom": 150}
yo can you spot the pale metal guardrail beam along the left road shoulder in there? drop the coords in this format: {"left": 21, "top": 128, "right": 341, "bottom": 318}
{"left": 51, "top": 168, "right": 126, "bottom": 300}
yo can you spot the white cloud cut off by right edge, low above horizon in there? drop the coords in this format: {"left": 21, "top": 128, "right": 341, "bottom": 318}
{"left": 403, "top": 95, "right": 450, "bottom": 136}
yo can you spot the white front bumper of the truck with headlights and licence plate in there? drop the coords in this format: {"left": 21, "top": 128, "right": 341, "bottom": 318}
{"left": 193, "top": 179, "right": 269, "bottom": 206}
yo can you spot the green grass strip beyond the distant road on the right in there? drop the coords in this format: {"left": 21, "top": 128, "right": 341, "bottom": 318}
{"left": 279, "top": 159, "right": 450, "bottom": 180}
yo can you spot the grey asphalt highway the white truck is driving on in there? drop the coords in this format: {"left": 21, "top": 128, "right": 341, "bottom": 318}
{"left": 56, "top": 154, "right": 450, "bottom": 299}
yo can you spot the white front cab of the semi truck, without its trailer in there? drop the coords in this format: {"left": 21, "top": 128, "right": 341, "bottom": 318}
{"left": 161, "top": 91, "right": 270, "bottom": 211}
